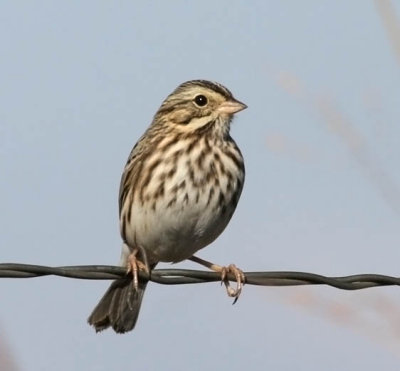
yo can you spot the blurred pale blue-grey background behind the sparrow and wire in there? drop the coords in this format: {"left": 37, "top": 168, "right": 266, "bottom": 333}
{"left": 0, "top": 0, "right": 400, "bottom": 371}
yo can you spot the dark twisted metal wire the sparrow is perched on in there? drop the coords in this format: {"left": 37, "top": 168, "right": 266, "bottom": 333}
{"left": 0, "top": 263, "right": 400, "bottom": 290}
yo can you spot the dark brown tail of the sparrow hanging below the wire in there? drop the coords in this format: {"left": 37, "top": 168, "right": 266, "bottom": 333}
{"left": 88, "top": 276, "right": 147, "bottom": 334}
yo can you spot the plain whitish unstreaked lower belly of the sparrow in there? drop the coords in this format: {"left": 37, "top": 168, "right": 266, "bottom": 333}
{"left": 126, "top": 182, "right": 233, "bottom": 262}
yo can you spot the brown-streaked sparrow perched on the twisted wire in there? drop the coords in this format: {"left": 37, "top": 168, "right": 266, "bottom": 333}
{"left": 88, "top": 80, "right": 247, "bottom": 333}
